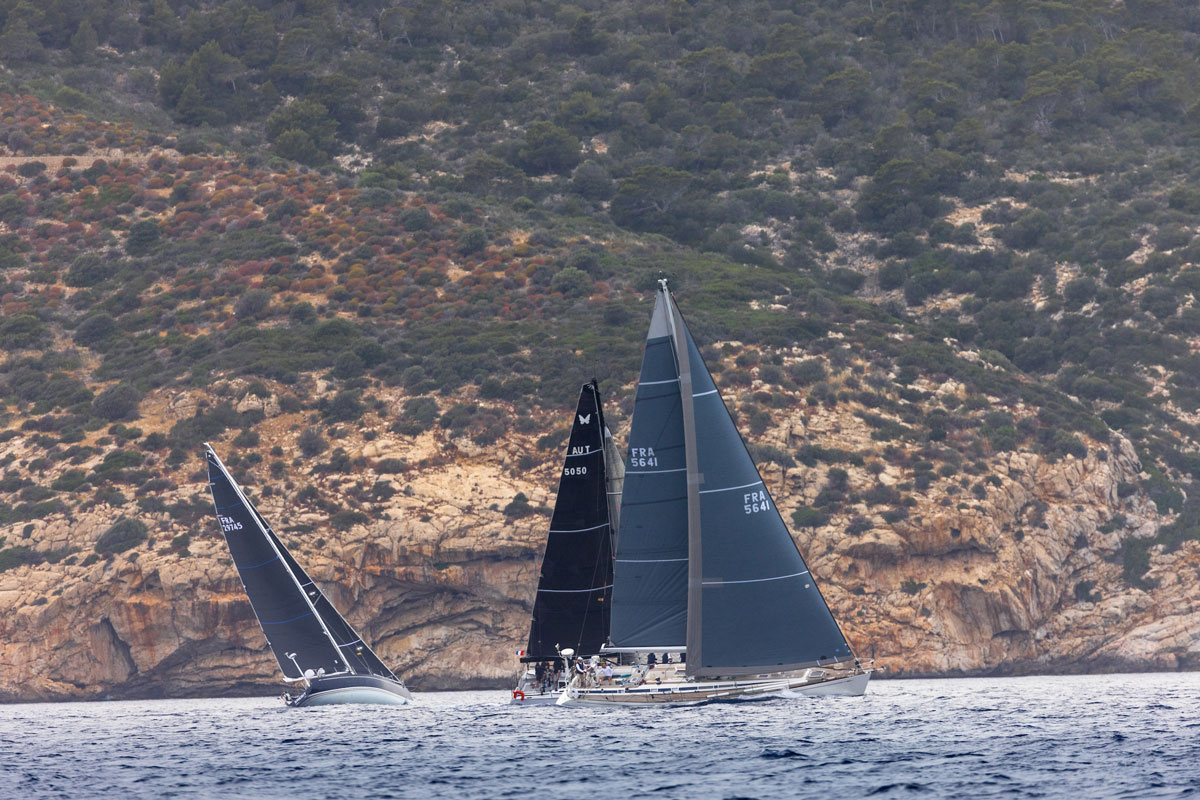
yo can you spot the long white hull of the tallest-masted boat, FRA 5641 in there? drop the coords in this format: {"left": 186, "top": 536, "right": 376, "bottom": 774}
{"left": 557, "top": 670, "right": 871, "bottom": 705}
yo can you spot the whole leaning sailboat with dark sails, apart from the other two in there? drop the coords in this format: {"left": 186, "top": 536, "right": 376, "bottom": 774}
{"left": 204, "top": 444, "right": 410, "bottom": 706}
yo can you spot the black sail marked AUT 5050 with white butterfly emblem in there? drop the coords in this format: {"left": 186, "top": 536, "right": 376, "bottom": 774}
{"left": 526, "top": 384, "right": 612, "bottom": 660}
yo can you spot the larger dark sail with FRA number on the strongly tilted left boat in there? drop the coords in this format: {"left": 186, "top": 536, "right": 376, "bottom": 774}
{"left": 206, "top": 451, "right": 346, "bottom": 680}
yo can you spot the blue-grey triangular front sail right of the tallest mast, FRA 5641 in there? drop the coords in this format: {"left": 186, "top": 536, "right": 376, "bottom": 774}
{"left": 679, "top": 318, "right": 853, "bottom": 676}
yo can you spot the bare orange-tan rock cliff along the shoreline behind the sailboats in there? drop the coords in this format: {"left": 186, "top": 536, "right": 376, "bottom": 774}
{"left": 0, "top": 369, "right": 1200, "bottom": 700}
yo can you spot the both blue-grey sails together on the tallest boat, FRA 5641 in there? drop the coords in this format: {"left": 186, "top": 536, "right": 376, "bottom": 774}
{"left": 610, "top": 281, "right": 853, "bottom": 678}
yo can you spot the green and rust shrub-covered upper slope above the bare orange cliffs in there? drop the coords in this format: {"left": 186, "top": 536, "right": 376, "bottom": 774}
{"left": 0, "top": 0, "right": 1200, "bottom": 581}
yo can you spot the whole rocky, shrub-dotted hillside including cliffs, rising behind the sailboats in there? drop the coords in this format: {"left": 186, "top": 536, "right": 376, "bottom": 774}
{"left": 7, "top": 14, "right": 1200, "bottom": 699}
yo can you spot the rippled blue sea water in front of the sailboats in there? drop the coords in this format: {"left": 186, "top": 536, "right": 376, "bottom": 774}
{"left": 0, "top": 673, "right": 1200, "bottom": 800}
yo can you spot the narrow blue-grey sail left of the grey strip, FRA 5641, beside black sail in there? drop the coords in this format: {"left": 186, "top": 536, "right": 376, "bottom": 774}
{"left": 610, "top": 296, "right": 688, "bottom": 648}
